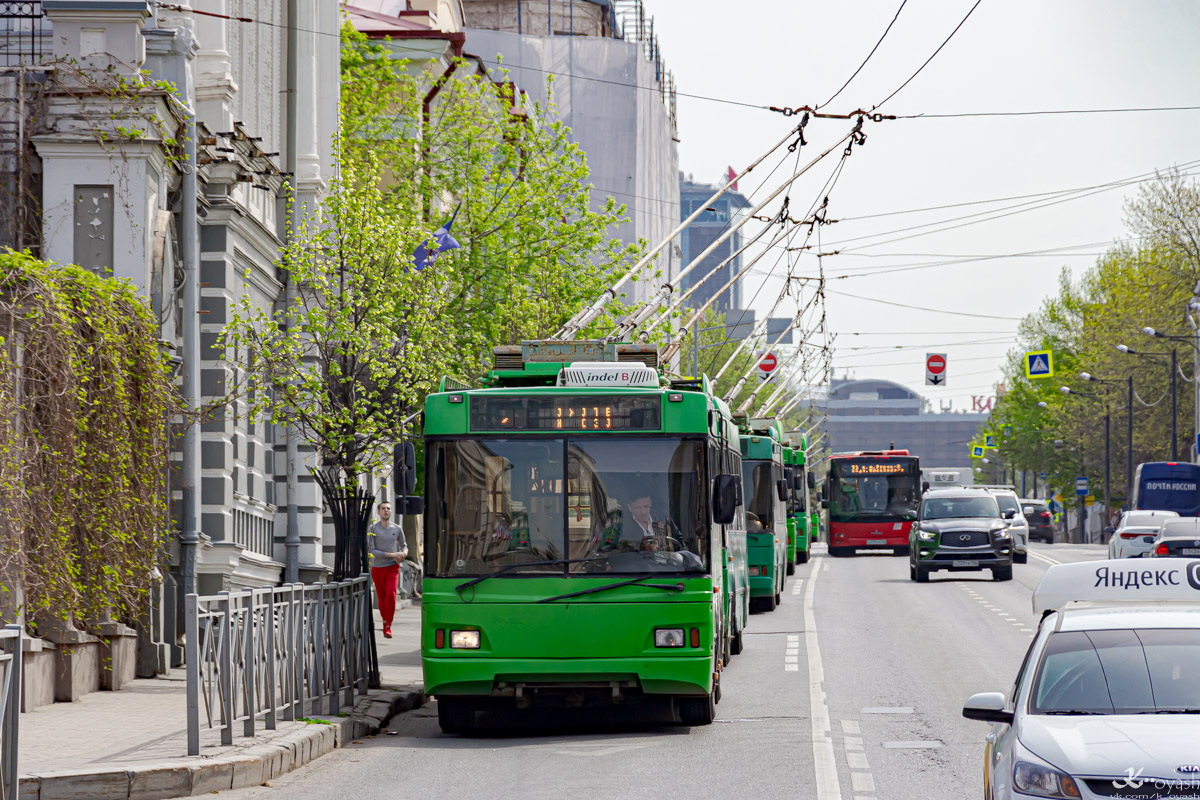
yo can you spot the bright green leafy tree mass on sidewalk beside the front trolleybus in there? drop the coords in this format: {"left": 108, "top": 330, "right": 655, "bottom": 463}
{"left": 224, "top": 26, "right": 636, "bottom": 578}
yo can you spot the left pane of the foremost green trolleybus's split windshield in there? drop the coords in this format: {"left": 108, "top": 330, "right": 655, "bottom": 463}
{"left": 426, "top": 439, "right": 564, "bottom": 576}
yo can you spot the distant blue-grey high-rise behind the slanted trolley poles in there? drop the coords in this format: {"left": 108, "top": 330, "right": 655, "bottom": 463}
{"left": 679, "top": 173, "right": 749, "bottom": 313}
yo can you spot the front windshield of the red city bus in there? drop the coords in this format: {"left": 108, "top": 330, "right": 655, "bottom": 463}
{"left": 829, "top": 458, "right": 920, "bottom": 522}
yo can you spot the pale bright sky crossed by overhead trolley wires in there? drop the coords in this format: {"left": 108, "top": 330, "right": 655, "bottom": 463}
{"left": 646, "top": 0, "right": 1200, "bottom": 411}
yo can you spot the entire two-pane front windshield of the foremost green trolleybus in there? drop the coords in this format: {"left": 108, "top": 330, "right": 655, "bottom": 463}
{"left": 426, "top": 437, "right": 709, "bottom": 577}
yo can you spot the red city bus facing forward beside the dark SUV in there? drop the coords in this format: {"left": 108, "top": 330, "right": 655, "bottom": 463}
{"left": 822, "top": 450, "right": 922, "bottom": 555}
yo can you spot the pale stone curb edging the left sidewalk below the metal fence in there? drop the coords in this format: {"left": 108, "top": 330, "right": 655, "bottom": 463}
{"left": 18, "top": 688, "right": 426, "bottom": 800}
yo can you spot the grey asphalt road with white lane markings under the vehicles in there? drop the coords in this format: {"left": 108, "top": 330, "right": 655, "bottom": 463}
{"left": 228, "top": 545, "right": 1105, "bottom": 800}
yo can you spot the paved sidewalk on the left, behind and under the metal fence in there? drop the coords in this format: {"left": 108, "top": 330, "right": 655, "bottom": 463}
{"left": 18, "top": 601, "right": 424, "bottom": 800}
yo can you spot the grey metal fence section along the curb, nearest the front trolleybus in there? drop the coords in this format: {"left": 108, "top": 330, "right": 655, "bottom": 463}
{"left": 185, "top": 576, "right": 373, "bottom": 756}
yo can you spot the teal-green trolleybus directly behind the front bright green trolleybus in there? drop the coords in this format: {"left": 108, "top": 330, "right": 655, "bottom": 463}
{"left": 740, "top": 420, "right": 788, "bottom": 612}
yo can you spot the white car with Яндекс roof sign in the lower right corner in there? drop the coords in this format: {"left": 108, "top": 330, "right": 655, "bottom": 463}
{"left": 962, "top": 559, "right": 1200, "bottom": 800}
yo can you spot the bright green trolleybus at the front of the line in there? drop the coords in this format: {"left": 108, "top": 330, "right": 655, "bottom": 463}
{"left": 421, "top": 341, "right": 742, "bottom": 733}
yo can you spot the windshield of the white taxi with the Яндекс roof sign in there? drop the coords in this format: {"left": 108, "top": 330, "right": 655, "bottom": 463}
{"left": 1030, "top": 628, "right": 1200, "bottom": 714}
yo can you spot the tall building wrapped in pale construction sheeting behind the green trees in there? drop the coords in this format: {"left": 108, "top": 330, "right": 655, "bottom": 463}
{"left": 462, "top": 0, "right": 680, "bottom": 301}
